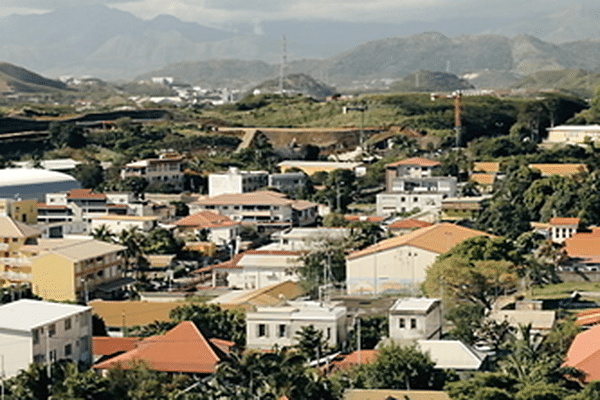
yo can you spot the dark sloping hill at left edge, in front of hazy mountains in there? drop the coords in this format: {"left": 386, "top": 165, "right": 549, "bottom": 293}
{"left": 0, "top": 63, "right": 67, "bottom": 93}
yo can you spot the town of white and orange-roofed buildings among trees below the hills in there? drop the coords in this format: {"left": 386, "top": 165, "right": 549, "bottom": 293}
{"left": 0, "top": 81, "right": 600, "bottom": 400}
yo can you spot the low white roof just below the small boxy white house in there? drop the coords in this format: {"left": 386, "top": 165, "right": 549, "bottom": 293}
{"left": 417, "top": 340, "right": 485, "bottom": 370}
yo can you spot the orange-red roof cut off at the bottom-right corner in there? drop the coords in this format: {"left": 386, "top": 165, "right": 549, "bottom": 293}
{"left": 563, "top": 325, "right": 600, "bottom": 382}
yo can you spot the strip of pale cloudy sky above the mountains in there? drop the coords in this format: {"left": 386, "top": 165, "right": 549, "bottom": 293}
{"left": 0, "top": 0, "right": 600, "bottom": 26}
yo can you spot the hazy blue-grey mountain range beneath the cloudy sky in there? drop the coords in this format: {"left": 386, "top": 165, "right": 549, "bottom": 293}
{"left": 0, "top": 5, "right": 600, "bottom": 88}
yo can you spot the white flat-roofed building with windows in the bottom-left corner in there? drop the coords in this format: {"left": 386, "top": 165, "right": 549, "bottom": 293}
{"left": 0, "top": 300, "right": 92, "bottom": 377}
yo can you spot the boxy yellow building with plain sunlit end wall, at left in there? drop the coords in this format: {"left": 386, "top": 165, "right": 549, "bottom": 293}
{"left": 23, "top": 239, "right": 133, "bottom": 301}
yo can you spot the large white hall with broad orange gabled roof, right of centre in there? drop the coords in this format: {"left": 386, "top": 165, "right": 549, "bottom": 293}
{"left": 346, "top": 223, "right": 491, "bottom": 294}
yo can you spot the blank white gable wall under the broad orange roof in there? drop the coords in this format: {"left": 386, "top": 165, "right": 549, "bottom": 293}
{"left": 346, "top": 246, "right": 438, "bottom": 294}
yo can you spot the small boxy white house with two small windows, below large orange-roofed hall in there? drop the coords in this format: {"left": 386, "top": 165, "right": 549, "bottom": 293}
{"left": 389, "top": 297, "right": 442, "bottom": 340}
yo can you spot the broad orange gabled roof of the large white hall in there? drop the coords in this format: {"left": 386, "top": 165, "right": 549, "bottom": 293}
{"left": 347, "top": 223, "right": 495, "bottom": 260}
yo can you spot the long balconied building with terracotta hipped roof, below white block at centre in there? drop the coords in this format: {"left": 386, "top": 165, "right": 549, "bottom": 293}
{"left": 189, "top": 191, "right": 319, "bottom": 228}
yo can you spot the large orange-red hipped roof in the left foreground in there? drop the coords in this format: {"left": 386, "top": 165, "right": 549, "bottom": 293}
{"left": 92, "top": 321, "right": 221, "bottom": 374}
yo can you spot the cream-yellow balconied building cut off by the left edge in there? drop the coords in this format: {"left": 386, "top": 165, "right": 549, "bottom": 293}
{"left": 0, "top": 216, "right": 42, "bottom": 286}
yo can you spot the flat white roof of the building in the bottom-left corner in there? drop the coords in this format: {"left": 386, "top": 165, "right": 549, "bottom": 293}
{"left": 0, "top": 299, "right": 91, "bottom": 331}
